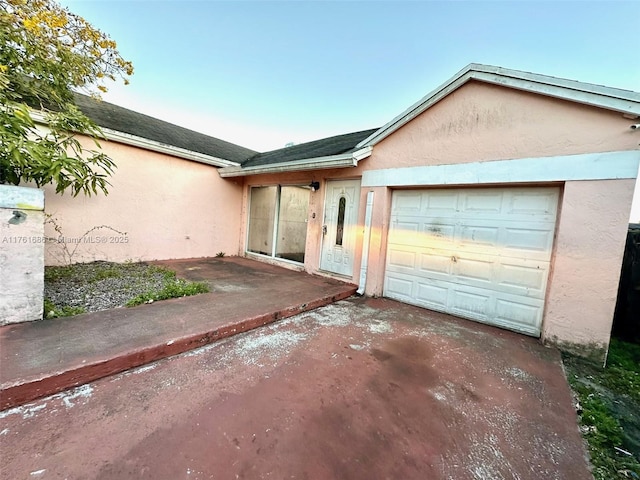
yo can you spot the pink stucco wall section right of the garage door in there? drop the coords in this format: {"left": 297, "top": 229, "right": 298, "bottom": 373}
{"left": 542, "top": 179, "right": 635, "bottom": 354}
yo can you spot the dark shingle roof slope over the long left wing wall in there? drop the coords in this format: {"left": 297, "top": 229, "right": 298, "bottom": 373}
{"left": 75, "top": 94, "right": 256, "bottom": 163}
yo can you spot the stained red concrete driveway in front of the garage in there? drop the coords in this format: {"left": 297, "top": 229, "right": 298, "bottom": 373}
{"left": 0, "top": 298, "right": 591, "bottom": 480}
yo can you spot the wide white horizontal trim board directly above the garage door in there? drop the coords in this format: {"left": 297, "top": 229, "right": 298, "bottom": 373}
{"left": 362, "top": 151, "right": 640, "bottom": 187}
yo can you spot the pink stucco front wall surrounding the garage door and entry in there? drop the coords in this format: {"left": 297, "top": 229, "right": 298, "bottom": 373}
{"left": 235, "top": 82, "right": 637, "bottom": 359}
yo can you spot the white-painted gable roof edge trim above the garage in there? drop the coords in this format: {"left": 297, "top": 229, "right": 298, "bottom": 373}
{"left": 357, "top": 63, "right": 640, "bottom": 148}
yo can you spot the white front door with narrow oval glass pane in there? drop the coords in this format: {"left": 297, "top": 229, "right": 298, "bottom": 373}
{"left": 320, "top": 180, "right": 360, "bottom": 276}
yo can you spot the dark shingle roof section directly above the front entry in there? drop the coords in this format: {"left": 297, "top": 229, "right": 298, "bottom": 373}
{"left": 242, "top": 128, "right": 378, "bottom": 168}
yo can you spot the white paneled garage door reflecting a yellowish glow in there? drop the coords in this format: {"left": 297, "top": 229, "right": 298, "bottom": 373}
{"left": 384, "top": 188, "right": 558, "bottom": 336}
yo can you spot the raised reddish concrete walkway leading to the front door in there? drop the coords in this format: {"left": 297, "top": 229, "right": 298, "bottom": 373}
{"left": 0, "top": 257, "right": 356, "bottom": 410}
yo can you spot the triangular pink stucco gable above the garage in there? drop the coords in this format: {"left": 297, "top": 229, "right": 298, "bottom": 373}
{"left": 365, "top": 82, "right": 638, "bottom": 169}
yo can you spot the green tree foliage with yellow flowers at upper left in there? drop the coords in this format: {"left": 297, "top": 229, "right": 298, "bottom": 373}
{"left": 0, "top": 0, "right": 133, "bottom": 196}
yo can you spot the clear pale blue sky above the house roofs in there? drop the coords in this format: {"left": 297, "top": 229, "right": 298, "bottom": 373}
{"left": 61, "top": 0, "right": 640, "bottom": 151}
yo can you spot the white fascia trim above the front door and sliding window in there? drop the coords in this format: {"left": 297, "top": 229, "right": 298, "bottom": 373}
{"left": 218, "top": 147, "right": 373, "bottom": 178}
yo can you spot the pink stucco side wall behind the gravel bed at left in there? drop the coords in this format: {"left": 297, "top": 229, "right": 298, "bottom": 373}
{"left": 45, "top": 141, "right": 242, "bottom": 265}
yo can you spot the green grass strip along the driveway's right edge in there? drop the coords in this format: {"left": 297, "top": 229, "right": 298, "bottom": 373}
{"left": 564, "top": 339, "right": 640, "bottom": 480}
